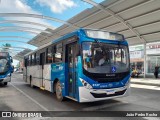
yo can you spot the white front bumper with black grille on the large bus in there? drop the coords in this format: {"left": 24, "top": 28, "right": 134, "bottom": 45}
{"left": 79, "top": 85, "right": 130, "bottom": 102}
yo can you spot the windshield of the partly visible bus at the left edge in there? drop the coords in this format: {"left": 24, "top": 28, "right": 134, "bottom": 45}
{"left": 0, "top": 56, "right": 9, "bottom": 73}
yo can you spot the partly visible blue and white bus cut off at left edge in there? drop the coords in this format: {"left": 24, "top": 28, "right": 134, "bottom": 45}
{"left": 0, "top": 52, "right": 13, "bottom": 85}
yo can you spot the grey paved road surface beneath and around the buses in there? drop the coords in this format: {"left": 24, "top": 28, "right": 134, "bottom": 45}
{"left": 0, "top": 74, "right": 160, "bottom": 120}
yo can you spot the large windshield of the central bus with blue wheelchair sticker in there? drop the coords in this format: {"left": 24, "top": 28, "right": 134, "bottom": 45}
{"left": 82, "top": 42, "right": 129, "bottom": 73}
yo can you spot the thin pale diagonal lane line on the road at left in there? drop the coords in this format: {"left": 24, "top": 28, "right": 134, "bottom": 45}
{"left": 10, "top": 83, "right": 49, "bottom": 111}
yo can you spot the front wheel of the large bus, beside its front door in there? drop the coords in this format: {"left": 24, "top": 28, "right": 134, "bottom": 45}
{"left": 56, "top": 81, "right": 63, "bottom": 101}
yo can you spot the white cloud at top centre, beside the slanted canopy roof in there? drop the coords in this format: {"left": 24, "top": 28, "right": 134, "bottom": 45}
{"left": 35, "top": 0, "right": 77, "bottom": 13}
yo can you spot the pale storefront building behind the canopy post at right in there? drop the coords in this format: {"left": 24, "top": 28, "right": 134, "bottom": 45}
{"left": 129, "top": 42, "right": 160, "bottom": 75}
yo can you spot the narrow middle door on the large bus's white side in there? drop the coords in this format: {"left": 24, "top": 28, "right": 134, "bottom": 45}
{"left": 40, "top": 52, "right": 45, "bottom": 89}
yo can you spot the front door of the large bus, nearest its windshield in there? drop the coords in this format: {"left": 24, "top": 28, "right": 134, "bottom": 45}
{"left": 66, "top": 43, "right": 77, "bottom": 98}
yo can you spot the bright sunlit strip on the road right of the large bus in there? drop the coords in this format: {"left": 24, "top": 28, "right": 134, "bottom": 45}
{"left": 131, "top": 84, "right": 160, "bottom": 90}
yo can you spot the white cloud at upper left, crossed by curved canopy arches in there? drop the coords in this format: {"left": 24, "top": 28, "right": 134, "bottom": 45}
{"left": 0, "top": 0, "right": 55, "bottom": 33}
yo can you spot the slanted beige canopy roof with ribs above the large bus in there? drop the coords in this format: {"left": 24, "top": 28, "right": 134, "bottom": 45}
{"left": 28, "top": 0, "right": 160, "bottom": 47}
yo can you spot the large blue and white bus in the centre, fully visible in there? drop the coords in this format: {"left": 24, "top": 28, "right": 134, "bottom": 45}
{"left": 24, "top": 29, "right": 130, "bottom": 102}
